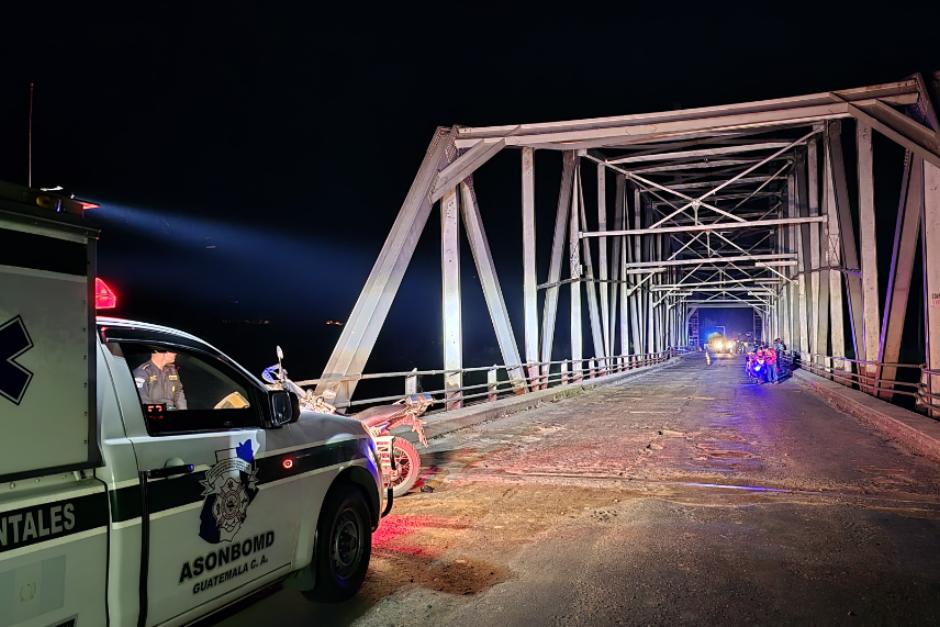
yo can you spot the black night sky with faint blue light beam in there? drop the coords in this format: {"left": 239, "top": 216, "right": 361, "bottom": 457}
{"left": 0, "top": 3, "right": 940, "bottom": 378}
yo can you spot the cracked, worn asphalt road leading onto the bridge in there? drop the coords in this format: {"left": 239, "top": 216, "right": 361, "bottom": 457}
{"left": 209, "top": 356, "right": 940, "bottom": 627}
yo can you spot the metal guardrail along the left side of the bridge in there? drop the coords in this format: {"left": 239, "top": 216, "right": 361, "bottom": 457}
{"left": 296, "top": 347, "right": 689, "bottom": 411}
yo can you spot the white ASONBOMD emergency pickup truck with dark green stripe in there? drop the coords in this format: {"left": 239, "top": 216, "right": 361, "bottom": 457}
{"left": 0, "top": 185, "right": 391, "bottom": 627}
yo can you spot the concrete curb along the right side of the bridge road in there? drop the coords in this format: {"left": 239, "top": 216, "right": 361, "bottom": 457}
{"left": 793, "top": 370, "right": 940, "bottom": 462}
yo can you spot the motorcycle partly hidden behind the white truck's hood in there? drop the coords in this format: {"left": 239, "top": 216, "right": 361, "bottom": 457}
{"left": 262, "top": 358, "right": 434, "bottom": 498}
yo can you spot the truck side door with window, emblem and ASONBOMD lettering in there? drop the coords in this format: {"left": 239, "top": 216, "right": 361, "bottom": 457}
{"left": 103, "top": 340, "right": 296, "bottom": 625}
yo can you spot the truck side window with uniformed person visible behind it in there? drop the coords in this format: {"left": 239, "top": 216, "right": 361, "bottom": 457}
{"left": 120, "top": 342, "right": 261, "bottom": 435}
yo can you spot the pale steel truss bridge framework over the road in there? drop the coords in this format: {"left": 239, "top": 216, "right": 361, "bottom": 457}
{"left": 306, "top": 73, "right": 940, "bottom": 416}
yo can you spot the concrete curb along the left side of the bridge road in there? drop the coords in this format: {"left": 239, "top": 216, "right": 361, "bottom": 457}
{"left": 420, "top": 357, "right": 681, "bottom": 440}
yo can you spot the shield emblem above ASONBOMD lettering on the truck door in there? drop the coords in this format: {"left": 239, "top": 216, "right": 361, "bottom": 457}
{"left": 199, "top": 440, "right": 258, "bottom": 544}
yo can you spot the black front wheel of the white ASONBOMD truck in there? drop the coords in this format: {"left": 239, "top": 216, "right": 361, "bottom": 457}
{"left": 304, "top": 484, "right": 372, "bottom": 603}
